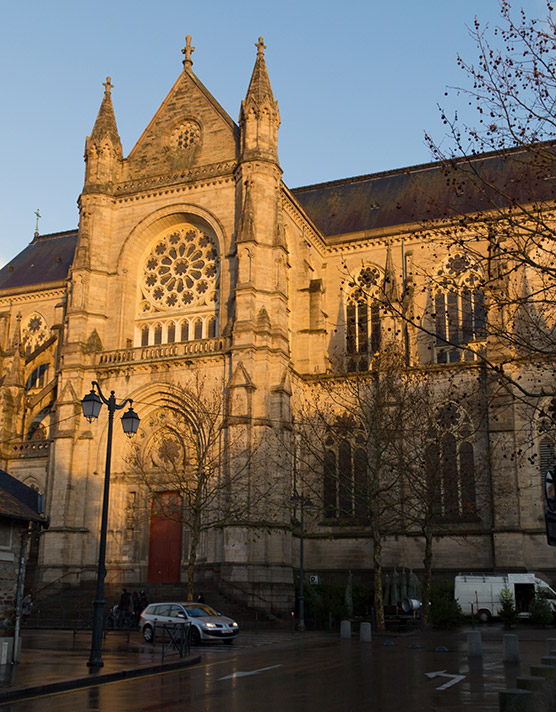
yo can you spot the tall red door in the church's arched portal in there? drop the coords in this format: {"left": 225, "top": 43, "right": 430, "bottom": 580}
{"left": 148, "top": 492, "right": 182, "bottom": 583}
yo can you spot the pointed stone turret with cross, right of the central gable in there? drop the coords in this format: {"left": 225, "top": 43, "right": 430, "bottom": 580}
{"left": 239, "top": 37, "right": 280, "bottom": 162}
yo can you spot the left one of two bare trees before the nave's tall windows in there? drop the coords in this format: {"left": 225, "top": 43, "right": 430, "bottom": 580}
{"left": 295, "top": 351, "right": 430, "bottom": 630}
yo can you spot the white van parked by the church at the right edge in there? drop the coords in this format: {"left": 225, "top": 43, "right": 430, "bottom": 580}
{"left": 454, "top": 573, "right": 556, "bottom": 623}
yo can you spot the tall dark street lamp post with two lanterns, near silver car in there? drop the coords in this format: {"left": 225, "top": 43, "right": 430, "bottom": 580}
{"left": 81, "top": 381, "right": 139, "bottom": 669}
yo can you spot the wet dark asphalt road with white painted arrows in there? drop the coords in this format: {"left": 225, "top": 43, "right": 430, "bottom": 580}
{"left": 0, "top": 634, "right": 546, "bottom": 712}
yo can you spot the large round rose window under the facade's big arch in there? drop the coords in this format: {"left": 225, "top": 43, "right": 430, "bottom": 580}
{"left": 141, "top": 225, "right": 219, "bottom": 311}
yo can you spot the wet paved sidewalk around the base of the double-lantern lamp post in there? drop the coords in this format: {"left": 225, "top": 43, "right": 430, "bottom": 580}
{"left": 0, "top": 630, "right": 201, "bottom": 704}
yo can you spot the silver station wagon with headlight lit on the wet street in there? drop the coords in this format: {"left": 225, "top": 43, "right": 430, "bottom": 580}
{"left": 139, "top": 602, "right": 239, "bottom": 645}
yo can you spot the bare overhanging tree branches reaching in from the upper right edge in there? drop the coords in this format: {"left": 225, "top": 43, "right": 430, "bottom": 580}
{"left": 360, "top": 0, "right": 556, "bottom": 397}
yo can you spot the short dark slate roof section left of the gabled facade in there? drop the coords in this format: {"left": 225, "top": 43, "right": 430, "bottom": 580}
{"left": 0, "top": 230, "right": 77, "bottom": 289}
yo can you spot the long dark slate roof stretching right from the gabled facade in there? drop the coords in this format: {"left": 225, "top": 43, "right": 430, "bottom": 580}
{"left": 291, "top": 144, "right": 556, "bottom": 237}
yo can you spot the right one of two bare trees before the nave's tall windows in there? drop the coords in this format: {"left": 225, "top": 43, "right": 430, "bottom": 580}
{"left": 399, "top": 369, "right": 492, "bottom": 626}
